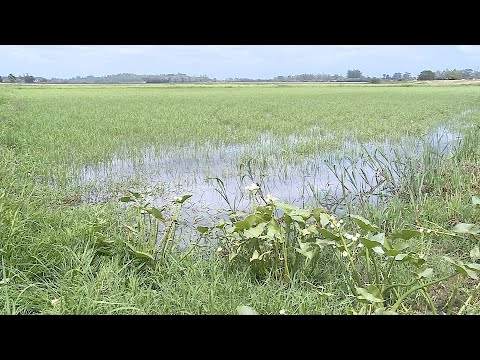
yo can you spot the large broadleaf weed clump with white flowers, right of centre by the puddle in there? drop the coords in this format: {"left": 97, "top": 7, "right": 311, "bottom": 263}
{"left": 198, "top": 183, "right": 480, "bottom": 314}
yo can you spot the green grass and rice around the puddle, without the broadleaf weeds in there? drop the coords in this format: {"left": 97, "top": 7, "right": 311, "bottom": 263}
{"left": 0, "top": 84, "right": 480, "bottom": 314}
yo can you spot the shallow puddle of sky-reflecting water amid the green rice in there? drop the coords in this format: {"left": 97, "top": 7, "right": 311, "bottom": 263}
{"left": 75, "top": 122, "right": 468, "bottom": 229}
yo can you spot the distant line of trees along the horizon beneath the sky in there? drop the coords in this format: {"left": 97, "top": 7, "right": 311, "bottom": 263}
{"left": 0, "top": 69, "right": 480, "bottom": 84}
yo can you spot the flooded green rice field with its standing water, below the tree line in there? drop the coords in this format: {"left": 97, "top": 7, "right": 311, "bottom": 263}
{"left": 0, "top": 81, "right": 480, "bottom": 315}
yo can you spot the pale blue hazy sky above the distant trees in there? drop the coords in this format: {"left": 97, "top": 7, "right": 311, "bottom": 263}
{"left": 0, "top": 45, "right": 480, "bottom": 79}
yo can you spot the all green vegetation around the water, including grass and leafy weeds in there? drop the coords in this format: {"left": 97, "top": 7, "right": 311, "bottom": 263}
{"left": 0, "top": 85, "right": 480, "bottom": 314}
